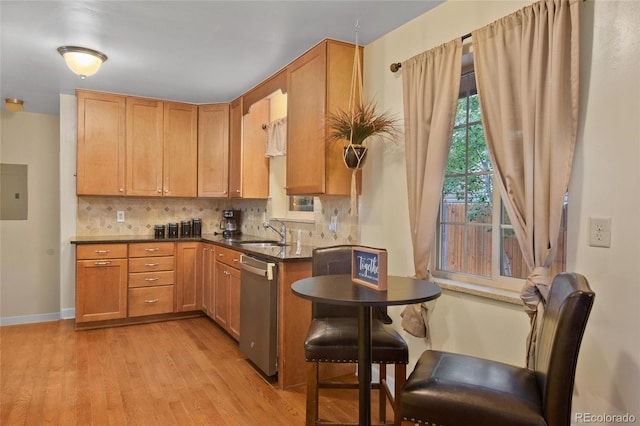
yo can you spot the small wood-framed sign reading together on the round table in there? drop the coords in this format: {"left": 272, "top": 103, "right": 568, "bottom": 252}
{"left": 351, "top": 247, "right": 387, "bottom": 291}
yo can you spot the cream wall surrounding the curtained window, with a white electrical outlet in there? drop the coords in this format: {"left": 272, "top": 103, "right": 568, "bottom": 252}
{"left": 360, "top": 0, "right": 640, "bottom": 418}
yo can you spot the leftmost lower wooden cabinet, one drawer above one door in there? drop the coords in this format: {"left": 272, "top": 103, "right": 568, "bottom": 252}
{"left": 76, "top": 244, "right": 127, "bottom": 323}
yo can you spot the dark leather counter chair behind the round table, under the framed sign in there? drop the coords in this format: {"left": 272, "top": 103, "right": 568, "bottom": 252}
{"left": 304, "top": 245, "right": 409, "bottom": 426}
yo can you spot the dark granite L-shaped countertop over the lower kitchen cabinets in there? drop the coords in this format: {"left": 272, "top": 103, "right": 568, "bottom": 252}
{"left": 71, "top": 234, "right": 314, "bottom": 262}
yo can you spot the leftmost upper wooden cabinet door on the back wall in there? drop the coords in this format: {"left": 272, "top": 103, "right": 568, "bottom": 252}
{"left": 76, "top": 90, "right": 125, "bottom": 195}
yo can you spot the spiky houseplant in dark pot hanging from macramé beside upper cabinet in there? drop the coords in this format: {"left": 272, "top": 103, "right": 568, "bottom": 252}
{"left": 327, "top": 101, "right": 398, "bottom": 169}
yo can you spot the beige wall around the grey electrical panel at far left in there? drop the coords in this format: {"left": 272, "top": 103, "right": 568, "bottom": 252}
{"left": 0, "top": 111, "right": 60, "bottom": 325}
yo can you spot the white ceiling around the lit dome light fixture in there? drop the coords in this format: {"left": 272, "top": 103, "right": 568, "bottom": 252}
{"left": 0, "top": 0, "right": 442, "bottom": 114}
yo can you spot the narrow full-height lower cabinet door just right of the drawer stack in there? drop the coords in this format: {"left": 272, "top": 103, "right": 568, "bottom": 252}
{"left": 176, "top": 242, "right": 203, "bottom": 312}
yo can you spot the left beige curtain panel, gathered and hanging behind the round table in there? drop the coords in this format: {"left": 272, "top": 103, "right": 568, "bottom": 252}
{"left": 402, "top": 39, "right": 462, "bottom": 341}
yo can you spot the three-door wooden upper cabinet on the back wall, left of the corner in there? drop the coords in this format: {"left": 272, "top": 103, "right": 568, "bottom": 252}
{"left": 76, "top": 90, "right": 198, "bottom": 197}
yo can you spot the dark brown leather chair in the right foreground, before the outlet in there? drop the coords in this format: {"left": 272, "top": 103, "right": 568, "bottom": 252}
{"left": 400, "top": 273, "right": 595, "bottom": 426}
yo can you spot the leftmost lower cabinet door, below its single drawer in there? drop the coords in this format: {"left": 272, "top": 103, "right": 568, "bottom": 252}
{"left": 76, "top": 259, "right": 127, "bottom": 323}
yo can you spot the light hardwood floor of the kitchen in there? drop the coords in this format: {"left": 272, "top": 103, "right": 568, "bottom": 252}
{"left": 0, "top": 317, "right": 393, "bottom": 426}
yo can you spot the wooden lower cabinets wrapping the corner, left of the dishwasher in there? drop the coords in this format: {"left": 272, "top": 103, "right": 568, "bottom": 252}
{"left": 76, "top": 241, "right": 241, "bottom": 340}
